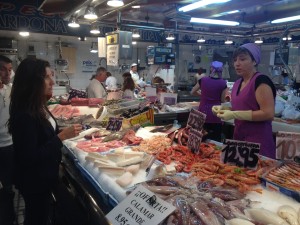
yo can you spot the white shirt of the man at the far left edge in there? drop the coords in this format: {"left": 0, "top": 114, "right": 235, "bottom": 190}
{"left": 0, "top": 84, "right": 12, "bottom": 147}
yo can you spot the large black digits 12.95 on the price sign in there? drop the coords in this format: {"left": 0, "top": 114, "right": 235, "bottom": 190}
{"left": 222, "top": 145, "right": 259, "bottom": 168}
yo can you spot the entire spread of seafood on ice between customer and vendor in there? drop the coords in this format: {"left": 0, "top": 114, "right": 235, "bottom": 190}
{"left": 56, "top": 102, "right": 300, "bottom": 225}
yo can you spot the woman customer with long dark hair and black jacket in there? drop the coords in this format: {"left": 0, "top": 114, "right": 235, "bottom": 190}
{"left": 8, "top": 58, "right": 82, "bottom": 225}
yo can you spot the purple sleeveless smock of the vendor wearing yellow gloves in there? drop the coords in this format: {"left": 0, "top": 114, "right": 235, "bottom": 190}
{"left": 231, "top": 73, "right": 275, "bottom": 158}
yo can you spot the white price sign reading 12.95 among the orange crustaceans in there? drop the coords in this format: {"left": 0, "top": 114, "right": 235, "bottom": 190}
{"left": 221, "top": 139, "right": 260, "bottom": 169}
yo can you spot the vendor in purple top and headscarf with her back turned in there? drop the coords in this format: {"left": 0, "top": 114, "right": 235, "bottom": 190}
{"left": 191, "top": 61, "right": 227, "bottom": 141}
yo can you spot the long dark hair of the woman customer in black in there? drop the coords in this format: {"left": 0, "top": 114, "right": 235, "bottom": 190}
{"left": 8, "top": 58, "right": 50, "bottom": 133}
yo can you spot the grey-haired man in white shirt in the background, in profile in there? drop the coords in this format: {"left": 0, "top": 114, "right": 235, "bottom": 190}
{"left": 87, "top": 67, "right": 107, "bottom": 98}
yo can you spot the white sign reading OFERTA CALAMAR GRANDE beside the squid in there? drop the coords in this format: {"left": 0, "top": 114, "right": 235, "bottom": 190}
{"left": 106, "top": 185, "right": 175, "bottom": 225}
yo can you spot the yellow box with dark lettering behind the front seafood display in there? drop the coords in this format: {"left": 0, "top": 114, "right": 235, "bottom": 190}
{"left": 122, "top": 109, "right": 154, "bottom": 128}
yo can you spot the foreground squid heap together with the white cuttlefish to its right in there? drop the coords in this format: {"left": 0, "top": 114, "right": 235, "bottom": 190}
{"left": 128, "top": 176, "right": 300, "bottom": 225}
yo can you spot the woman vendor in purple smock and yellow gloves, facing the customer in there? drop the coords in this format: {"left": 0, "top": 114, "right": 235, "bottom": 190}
{"left": 212, "top": 43, "right": 276, "bottom": 158}
